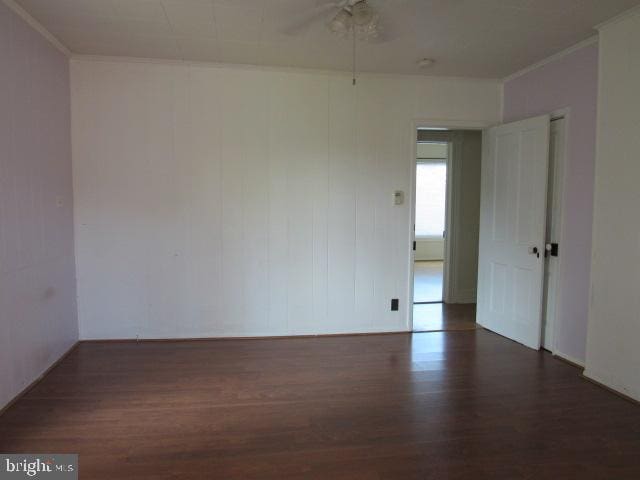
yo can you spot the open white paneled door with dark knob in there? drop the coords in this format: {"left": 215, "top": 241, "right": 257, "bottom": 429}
{"left": 477, "top": 115, "right": 551, "bottom": 349}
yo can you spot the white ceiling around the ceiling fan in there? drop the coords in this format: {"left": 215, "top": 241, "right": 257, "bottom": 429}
{"left": 12, "top": 0, "right": 640, "bottom": 78}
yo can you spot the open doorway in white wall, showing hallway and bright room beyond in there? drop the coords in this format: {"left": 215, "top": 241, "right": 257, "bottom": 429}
{"left": 412, "top": 128, "right": 482, "bottom": 332}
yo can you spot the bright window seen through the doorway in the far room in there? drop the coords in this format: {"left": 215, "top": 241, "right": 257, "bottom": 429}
{"left": 416, "top": 160, "right": 447, "bottom": 238}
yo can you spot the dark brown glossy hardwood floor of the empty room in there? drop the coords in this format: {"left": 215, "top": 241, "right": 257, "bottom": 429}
{"left": 0, "top": 330, "right": 640, "bottom": 480}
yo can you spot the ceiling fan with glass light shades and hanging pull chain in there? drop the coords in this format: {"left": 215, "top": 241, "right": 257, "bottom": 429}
{"left": 285, "top": 0, "right": 390, "bottom": 86}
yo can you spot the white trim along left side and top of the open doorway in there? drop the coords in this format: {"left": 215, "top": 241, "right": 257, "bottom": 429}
{"left": 406, "top": 118, "right": 493, "bottom": 332}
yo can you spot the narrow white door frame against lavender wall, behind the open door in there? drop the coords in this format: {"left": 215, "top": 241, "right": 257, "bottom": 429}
{"left": 543, "top": 107, "right": 571, "bottom": 355}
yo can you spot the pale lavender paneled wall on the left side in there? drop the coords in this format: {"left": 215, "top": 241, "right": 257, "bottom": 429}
{"left": 0, "top": 2, "right": 78, "bottom": 408}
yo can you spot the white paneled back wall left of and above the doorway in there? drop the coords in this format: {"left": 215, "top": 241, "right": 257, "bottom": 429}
{"left": 72, "top": 59, "right": 500, "bottom": 339}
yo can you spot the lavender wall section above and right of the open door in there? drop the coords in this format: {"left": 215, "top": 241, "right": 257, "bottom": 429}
{"left": 504, "top": 44, "right": 598, "bottom": 363}
